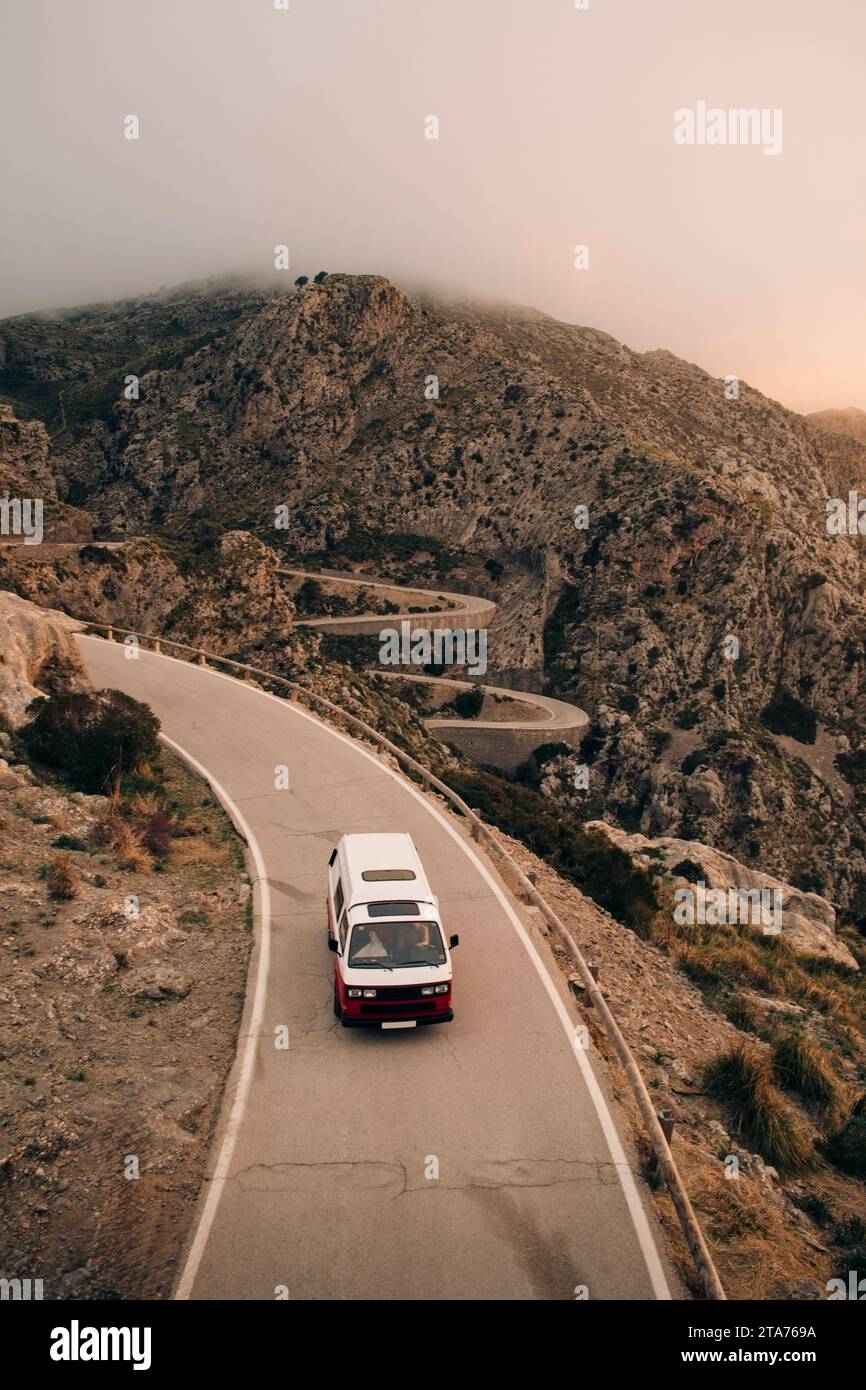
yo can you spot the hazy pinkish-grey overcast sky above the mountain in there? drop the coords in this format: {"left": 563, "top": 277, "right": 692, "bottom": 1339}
{"left": 0, "top": 0, "right": 866, "bottom": 410}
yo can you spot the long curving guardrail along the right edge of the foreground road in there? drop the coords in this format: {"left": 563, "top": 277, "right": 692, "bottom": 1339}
{"left": 78, "top": 619, "right": 727, "bottom": 1300}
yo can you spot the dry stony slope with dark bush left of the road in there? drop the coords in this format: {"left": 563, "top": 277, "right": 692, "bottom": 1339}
{"left": 0, "top": 692, "right": 252, "bottom": 1300}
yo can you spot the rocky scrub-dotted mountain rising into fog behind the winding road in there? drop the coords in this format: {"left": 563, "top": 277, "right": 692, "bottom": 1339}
{"left": 0, "top": 275, "right": 866, "bottom": 920}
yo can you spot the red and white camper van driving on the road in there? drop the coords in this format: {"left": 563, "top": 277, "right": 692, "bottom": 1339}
{"left": 328, "top": 834, "right": 459, "bottom": 1029}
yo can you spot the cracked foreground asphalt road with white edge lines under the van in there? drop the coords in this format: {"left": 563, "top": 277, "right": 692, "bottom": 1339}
{"left": 79, "top": 637, "right": 678, "bottom": 1300}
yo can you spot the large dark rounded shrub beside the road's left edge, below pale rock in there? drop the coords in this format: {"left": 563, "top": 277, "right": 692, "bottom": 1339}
{"left": 19, "top": 691, "right": 160, "bottom": 792}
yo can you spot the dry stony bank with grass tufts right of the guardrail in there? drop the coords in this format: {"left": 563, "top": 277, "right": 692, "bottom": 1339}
{"left": 494, "top": 837, "right": 866, "bottom": 1300}
